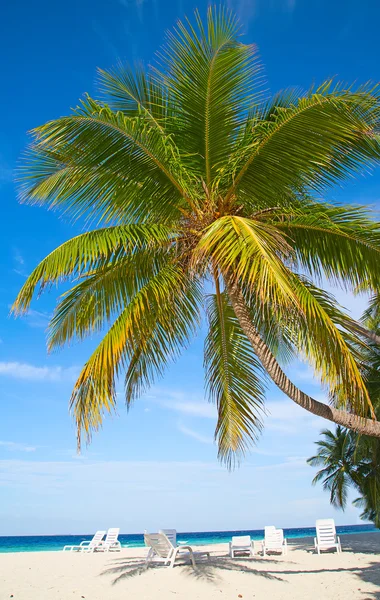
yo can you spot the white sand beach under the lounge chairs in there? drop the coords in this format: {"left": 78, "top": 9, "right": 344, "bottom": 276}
{"left": 0, "top": 533, "right": 380, "bottom": 600}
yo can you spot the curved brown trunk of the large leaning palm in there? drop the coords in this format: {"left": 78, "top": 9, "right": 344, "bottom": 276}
{"left": 225, "top": 278, "right": 380, "bottom": 437}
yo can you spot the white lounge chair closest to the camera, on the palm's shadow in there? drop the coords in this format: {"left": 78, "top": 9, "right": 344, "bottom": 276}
{"left": 144, "top": 532, "right": 210, "bottom": 568}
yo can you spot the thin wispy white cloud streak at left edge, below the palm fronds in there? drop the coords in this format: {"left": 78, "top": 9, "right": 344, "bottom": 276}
{"left": 0, "top": 362, "right": 79, "bottom": 382}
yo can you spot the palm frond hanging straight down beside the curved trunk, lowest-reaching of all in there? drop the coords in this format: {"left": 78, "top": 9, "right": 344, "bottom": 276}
{"left": 204, "top": 292, "right": 265, "bottom": 468}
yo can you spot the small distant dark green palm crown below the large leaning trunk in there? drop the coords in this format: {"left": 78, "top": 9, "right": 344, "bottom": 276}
{"left": 307, "top": 425, "right": 357, "bottom": 510}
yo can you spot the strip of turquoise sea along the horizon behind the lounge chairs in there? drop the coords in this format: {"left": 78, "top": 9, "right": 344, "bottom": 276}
{"left": 0, "top": 525, "right": 379, "bottom": 552}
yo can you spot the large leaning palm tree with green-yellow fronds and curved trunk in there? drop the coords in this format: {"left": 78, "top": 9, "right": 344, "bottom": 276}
{"left": 14, "top": 8, "right": 380, "bottom": 464}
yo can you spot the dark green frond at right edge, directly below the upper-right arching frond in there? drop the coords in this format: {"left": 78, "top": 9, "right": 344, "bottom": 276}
{"left": 270, "top": 200, "right": 380, "bottom": 289}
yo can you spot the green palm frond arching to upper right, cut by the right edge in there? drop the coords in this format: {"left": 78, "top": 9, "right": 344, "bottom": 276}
{"left": 225, "top": 80, "right": 380, "bottom": 205}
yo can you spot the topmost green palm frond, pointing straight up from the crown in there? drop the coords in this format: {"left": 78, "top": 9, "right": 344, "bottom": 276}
{"left": 161, "top": 7, "right": 260, "bottom": 183}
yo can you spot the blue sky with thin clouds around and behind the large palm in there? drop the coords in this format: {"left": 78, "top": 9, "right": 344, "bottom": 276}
{"left": 0, "top": 0, "right": 380, "bottom": 535}
